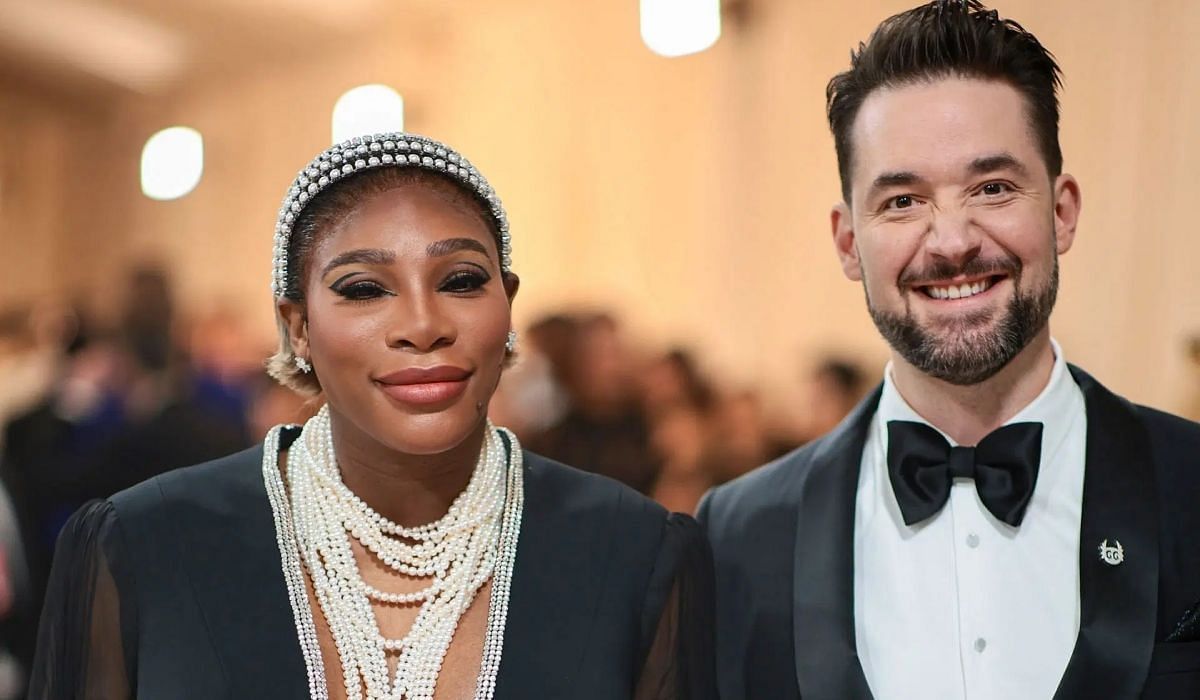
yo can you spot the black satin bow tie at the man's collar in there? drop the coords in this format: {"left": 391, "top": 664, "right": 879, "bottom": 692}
{"left": 888, "top": 420, "right": 1042, "bottom": 527}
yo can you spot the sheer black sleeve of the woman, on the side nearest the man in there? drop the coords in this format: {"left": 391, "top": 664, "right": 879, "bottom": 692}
{"left": 634, "top": 513, "right": 716, "bottom": 700}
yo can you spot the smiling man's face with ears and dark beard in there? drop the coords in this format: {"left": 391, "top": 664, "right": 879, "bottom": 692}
{"left": 833, "top": 78, "right": 1079, "bottom": 384}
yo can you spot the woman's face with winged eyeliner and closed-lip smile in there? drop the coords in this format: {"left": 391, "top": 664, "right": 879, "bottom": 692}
{"left": 282, "top": 181, "right": 516, "bottom": 455}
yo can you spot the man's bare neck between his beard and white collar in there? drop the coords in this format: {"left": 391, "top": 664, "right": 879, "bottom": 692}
{"left": 892, "top": 329, "right": 1055, "bottom": 445}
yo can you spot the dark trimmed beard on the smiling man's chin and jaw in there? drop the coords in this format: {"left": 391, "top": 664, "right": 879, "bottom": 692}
{"left": 864, "top": 257, "right": 1058, "bottom": 387}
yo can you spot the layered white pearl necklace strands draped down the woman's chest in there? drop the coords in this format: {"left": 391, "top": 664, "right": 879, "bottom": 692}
{"left": 263, "top": 406, "right": 524, "bottom": 700}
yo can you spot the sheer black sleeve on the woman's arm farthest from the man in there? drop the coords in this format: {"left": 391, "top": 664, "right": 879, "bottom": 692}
{"left": 29, "top": 501, "right": 134, "bottom": 700}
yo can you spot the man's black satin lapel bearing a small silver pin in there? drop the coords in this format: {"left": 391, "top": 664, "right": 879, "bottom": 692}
{"left": 1055, "top": 367, "right": 1158, "bottom": 700}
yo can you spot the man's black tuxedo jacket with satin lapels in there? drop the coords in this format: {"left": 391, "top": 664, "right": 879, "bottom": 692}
{"left": 698, "top": 367, "right": 1200, "bottom": 700}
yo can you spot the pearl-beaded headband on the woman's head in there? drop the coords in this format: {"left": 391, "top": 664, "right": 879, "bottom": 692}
{"left": 271, "top": 132, "right": 512, "bottom": 299}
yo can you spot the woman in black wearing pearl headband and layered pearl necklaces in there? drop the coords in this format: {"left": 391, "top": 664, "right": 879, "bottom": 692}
{"left": 32, "top": 133, "right": 714, "bottom": 700}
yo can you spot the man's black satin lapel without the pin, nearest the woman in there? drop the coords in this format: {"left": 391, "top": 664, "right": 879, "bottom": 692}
{"left": 792, "top": 389, "right": 881, "bottom": 700}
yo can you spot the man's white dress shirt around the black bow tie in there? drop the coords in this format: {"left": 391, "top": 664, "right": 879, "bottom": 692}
{"left": 854, "top": 342, "right": 1087, "bottom": 700}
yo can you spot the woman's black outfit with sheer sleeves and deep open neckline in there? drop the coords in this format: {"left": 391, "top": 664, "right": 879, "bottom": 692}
{"left": 30, "top": 430, "right": 716, "bottom": 700}
